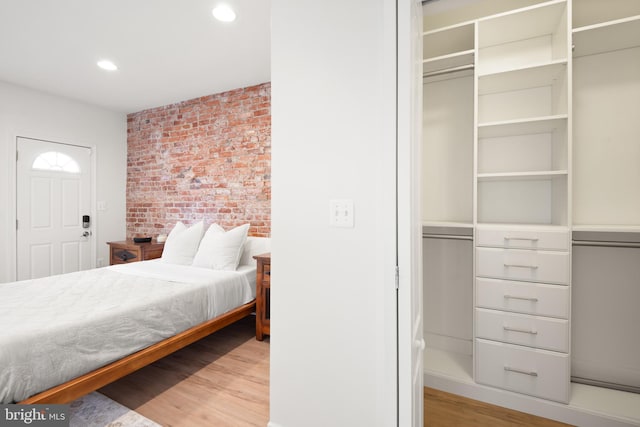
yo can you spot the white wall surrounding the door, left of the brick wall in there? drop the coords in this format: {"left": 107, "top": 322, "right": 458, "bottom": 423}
{"left": 0, "top": 82, "right": 127, "bottom": 283}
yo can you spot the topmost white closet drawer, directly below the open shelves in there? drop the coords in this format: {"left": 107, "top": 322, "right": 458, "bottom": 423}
{"left": 476, "top": 226, "right": 571, "bottom": 251}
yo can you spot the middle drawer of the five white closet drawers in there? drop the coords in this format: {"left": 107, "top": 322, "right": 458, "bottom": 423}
{"left": 476, "top": 277, "right": 569, "bottom": 319}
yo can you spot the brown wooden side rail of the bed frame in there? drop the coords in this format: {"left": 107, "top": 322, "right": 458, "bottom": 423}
{"left": 18, "top": 300, "right": 256, "bottom": 404}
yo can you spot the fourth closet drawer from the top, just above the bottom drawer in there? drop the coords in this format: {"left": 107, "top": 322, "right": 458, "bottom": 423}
{"left": 476, "top": 308, "right": 569, "bottom": 353}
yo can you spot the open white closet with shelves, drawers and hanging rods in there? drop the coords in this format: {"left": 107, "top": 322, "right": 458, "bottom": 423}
{"left": 422, "top": 0, "right": 640, "bottom": 425}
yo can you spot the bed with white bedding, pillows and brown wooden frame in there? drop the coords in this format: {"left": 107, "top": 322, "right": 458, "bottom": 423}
{"left": 0, "top": 222, "right": 269, "bottom": 403}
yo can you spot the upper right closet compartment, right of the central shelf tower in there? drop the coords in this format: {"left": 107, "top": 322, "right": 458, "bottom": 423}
{"left": 573, "top": 0, "right": 640, "bottom": 232}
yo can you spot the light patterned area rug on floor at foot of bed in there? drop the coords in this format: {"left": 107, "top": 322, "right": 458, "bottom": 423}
{"left": 69, "top": 392, "right": 161, "bottom": 427}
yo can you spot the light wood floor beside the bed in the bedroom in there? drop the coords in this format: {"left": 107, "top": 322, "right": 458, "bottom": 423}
{"left": 99, "top": 316, "right": 269, "bottom": 427}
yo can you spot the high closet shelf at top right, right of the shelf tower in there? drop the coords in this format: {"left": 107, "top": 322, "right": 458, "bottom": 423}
{"left": 573, "top": 15, "right": 640, "bottom": 57}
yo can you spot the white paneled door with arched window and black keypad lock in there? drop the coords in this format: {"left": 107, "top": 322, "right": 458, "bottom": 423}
{"left": 16, "top": 138, "right": 92, "bottom": 280}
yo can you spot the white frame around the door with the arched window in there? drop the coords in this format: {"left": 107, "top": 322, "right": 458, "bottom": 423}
{"left": 7, "top": 131, "right": 98, "bottom": 281}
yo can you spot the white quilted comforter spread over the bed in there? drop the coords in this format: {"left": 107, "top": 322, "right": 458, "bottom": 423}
{"left": 0, "top": 261, "right": 255, "bottom": 403}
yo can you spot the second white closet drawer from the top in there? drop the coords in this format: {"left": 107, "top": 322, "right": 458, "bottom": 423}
{"left": 476, "top": 248, "right": 570, "bottom": 284}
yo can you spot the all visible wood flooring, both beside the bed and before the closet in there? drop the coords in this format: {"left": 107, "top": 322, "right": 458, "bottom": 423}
{"left": 99, "top": 317, "right": 566, "bottom": 427}
